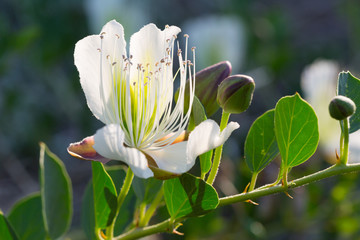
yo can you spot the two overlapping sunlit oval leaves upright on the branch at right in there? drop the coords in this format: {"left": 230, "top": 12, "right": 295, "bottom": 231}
{"left": 245, "top": 94, "right": 319, "bottom": 174}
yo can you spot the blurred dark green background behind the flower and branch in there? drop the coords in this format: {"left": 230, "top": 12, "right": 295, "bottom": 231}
{"left": 0, "top": 0, "right": 360, "bottom": 240}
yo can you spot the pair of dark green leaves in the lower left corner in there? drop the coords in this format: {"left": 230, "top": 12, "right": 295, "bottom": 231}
{"left": 0, "top": 143, "right": 72, "bottom": 240}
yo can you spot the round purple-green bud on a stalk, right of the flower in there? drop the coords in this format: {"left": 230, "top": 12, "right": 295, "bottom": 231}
{"left": 217, "top": 75, "right": 255, "bottom": 113}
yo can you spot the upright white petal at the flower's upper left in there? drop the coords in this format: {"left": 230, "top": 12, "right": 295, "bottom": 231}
{"left": 74, "top": 20, "right": 126, "bottom": 123}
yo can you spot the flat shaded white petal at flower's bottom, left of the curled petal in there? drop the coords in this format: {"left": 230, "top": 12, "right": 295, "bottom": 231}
{"left": 144, "top": 141, "right": 188, "bottom": 174}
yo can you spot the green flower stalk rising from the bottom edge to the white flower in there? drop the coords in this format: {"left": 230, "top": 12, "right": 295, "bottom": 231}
{"left": 106, "top": 168, "right": 134, "bottom": 240}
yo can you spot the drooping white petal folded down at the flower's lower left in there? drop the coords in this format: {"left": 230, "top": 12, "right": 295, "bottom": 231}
{"left": 93, "top": 124, "right": 153, "bottom": 178}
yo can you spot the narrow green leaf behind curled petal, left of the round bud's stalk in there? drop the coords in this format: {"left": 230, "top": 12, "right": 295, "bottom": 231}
{"left": 188, "top": 96, "right": 213, "bottom": 175}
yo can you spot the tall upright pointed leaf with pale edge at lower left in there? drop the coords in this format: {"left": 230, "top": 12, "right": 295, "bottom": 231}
{"left": 40, "top": 143, "right": 72, "bottom": 239}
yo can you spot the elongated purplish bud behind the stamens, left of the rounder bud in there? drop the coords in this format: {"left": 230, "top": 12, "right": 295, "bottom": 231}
{"left": 175, "top": 61, "right": 231, "bottom": 117}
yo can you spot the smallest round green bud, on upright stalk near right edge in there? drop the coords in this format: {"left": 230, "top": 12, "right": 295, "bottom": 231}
{"left": 329, "top": 95, "right": 356, "bottom": 120}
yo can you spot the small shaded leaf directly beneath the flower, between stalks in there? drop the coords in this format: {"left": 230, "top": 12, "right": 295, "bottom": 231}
{"left": 132, "top": 177, "right": 163, "bottom": 204}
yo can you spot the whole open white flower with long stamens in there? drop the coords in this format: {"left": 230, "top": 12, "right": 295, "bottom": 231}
{"left": 68, "top": 20, "right": 239, "bottom": 178}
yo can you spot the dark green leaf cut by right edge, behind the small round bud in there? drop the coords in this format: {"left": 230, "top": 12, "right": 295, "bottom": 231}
{"left": 337, "top": 72, "right": 360, "bottom": 133}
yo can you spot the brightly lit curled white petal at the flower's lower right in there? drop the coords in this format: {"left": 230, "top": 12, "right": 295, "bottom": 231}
{"left": 187, "top": 119, "right": 240, "bottom": 168}
